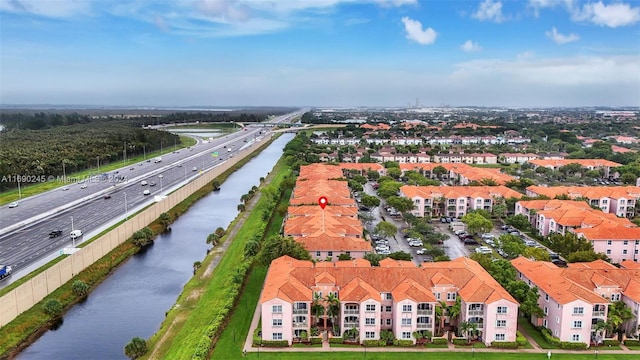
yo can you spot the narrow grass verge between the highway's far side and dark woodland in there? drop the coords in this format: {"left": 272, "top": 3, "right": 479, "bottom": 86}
{"left": 0, "top": 135, "right": 196, "bottom": 205}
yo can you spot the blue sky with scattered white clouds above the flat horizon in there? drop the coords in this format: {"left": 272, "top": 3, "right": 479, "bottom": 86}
{"left": 0, "top": 0, "right": 640, "bottom": 107}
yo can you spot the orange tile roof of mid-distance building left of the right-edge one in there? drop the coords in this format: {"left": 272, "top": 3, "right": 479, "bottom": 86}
{"left": 400, "top": 185, "right": 522, "bottom": 199}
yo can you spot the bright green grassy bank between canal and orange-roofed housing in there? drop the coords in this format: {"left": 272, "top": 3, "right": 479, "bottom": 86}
{"left": 148, "top": 161, "right": 290, "bottom": 359}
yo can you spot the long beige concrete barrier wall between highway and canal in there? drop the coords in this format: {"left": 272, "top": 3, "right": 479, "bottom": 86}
{"left": 0, "top": 137, "right": 269, "bottom": 328}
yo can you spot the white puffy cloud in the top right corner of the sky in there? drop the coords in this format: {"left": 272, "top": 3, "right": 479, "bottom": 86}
{"left": 572, "top": 1, "right": 640, "bottom": 28}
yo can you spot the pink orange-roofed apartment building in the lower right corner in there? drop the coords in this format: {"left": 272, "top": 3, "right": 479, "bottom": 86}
{"left": 511, "top": 257, "right": 640, "bottom": 344}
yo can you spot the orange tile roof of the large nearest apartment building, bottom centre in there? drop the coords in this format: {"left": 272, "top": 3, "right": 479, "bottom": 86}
{"left": 260, "top": 256, "right": 518, "bottom": 304}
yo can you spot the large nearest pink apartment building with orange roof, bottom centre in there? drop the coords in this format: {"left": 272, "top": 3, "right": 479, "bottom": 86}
{"left": 260, "top": 256, "right": 519, "bottom": 345}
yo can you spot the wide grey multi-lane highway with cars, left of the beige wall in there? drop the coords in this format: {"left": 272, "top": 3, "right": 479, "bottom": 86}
{"left": 0, "top": 111, "right": 301, "bottom": 287}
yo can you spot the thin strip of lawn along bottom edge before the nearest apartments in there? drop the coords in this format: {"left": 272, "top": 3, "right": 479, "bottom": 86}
{"left": 242, "top": 348, "right": 638, "bottom": 360}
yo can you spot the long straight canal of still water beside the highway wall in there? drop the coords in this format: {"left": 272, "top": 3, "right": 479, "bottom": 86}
{"left": 17, "top": 134, "right": 293, "bottom": 360}
